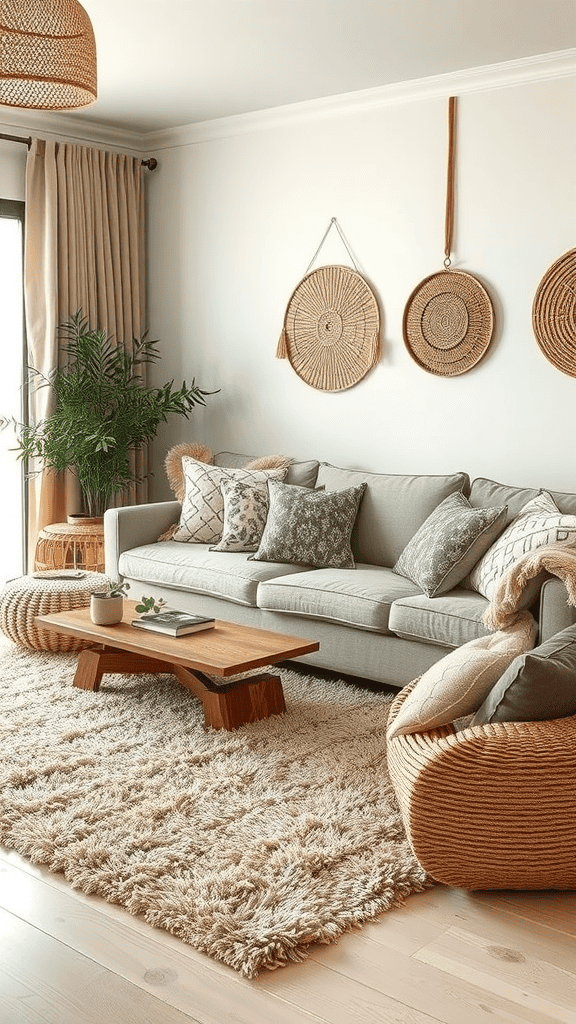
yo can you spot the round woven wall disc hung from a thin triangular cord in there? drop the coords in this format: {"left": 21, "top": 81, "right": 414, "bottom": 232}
{"left": 284, "top": 265, "right": 380, "bottom": 391}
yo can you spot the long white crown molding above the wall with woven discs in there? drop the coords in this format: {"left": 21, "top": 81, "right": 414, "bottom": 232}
{"left": 143, "top": 47, "right": 576, "bottom": 150}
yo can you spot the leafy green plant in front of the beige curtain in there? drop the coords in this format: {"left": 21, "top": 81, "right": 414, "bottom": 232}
{"left": 5, "top": 310, "right": 216, "bottom": 517}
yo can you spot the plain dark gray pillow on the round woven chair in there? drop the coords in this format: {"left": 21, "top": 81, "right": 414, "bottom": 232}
{"left": 471, "top": 625, "right": 576, "bottom": 725}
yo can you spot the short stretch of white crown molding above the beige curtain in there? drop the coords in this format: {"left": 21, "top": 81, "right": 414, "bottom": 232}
{"left": 0, "top": 105, "right": 147, "bottom": 157}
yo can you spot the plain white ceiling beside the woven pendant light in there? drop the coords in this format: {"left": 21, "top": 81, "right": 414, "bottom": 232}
{"left": 21, "top": 0, "right": 576, "bottom": 132}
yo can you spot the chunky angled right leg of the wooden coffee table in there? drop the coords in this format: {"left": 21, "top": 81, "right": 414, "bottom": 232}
{"left": 172, "top": 665, "right": 286, "bottom": 730}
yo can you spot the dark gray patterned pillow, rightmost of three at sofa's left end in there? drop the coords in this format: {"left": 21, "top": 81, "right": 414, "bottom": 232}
{"left": 251, "top": 480, "right": 366, "bottom": 569}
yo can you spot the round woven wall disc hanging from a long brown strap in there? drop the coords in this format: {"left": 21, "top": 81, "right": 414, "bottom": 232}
{"left": 404, "top": 270, "right": 494, "bottom": 377}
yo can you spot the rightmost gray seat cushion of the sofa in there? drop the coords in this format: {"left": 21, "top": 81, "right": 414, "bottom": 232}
{"left": 388, "top": 587, "right": 491, "bottom": 647}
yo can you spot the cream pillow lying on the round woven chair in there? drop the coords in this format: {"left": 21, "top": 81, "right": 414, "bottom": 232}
{"left": 387, "top": 611, "right": 537, "bottom": 739}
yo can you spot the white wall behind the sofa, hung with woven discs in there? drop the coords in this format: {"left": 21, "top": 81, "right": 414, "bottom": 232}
{"left": 149, "top": 68, "right": 576, "bottom": 498}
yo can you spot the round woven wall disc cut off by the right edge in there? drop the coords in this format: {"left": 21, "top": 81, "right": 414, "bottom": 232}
{"left": 532, "top": 249, "right": 576, "bottom": 377}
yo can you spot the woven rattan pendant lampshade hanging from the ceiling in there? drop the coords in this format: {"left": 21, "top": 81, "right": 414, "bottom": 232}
{"left": 0, "top": 0, "right": 96, "bottom": 111}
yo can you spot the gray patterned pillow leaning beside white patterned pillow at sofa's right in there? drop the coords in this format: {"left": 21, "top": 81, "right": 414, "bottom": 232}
{"left": 393, "top": 492, "right": 507, "bottom": 597}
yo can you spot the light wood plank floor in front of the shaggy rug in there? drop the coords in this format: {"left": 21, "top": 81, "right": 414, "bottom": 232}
{"left": 0, "top": 848, "right": 576, "bottom": 1024}
